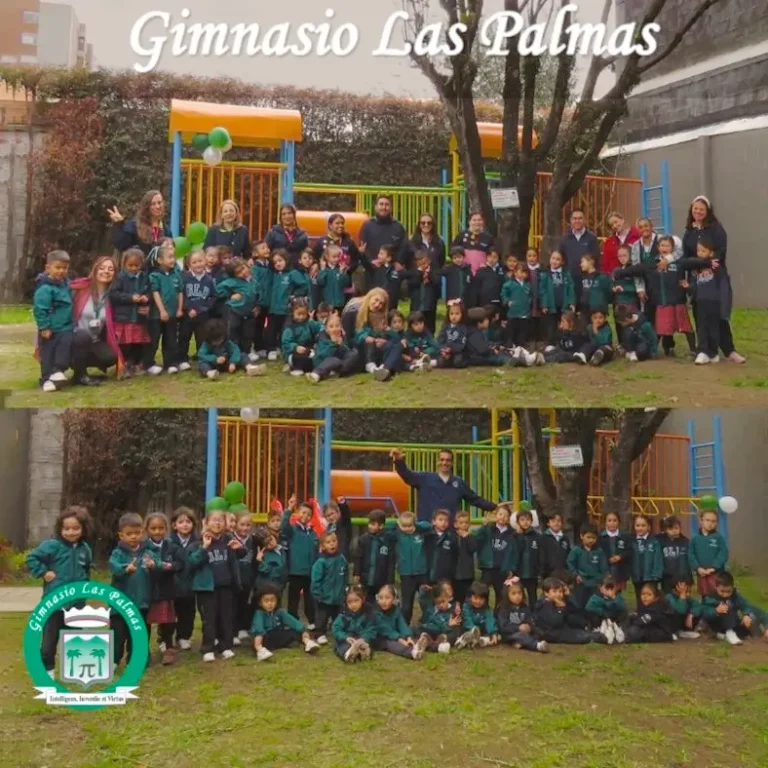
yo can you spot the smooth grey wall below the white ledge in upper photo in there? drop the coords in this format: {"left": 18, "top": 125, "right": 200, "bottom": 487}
{"left": 619, "top": 129, "right": 768, "bottom": 308}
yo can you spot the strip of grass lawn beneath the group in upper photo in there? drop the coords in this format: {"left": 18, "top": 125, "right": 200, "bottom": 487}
{"left": 0, "top": 310, "right": 768, "bottom": 408}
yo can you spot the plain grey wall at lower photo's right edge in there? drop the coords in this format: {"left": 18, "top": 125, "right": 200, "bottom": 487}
{"left": 662, "top": 408, "right": 768, "bottom": 573}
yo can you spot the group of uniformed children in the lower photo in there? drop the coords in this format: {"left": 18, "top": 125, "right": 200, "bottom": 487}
{"left": 27, "top": 498, "right": 768, "bottom": 674}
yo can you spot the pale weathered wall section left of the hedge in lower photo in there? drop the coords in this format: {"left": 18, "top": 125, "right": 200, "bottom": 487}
{"left": 26, "top": 409, "right": 66, "bottom": 546}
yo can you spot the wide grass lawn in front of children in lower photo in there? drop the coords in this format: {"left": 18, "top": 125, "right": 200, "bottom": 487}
{"left": 0, "top": 578, "right": 768, "bottom": 768}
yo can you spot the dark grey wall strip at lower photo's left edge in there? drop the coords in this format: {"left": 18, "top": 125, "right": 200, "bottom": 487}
{"left": 0, "top": 410, "right": 30, "bottom": 549}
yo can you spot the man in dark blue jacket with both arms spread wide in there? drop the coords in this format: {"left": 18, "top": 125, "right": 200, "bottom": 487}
{"left": 390, "top": 448, "right": 496, "bottom": 522}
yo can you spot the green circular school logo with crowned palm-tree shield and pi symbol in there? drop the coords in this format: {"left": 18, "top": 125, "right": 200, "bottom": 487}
{"left": 24, "top": 581, "right": 149, "bottom": 710}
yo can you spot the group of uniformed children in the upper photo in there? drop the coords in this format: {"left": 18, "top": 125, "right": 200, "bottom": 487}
{"left": 34, "top": 220, "right": 720, "bottom": 391}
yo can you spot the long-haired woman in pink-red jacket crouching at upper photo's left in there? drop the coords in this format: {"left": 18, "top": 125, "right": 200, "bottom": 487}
{"left": 69, "top": 256, "right": 123, "bottom": 386}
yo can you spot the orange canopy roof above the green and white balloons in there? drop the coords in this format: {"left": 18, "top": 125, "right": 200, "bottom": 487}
{"left": 168, "top": 99, "right": 302, "bottom": 147}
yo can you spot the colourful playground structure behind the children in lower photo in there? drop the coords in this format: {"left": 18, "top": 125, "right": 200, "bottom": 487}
{"left": 206, "top": 409, "right": 727, "bottom": 535}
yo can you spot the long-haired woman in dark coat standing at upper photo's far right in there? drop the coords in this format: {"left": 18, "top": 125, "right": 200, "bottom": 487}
{"left": 683, "top": 195, "right": 747, "bottom": 363}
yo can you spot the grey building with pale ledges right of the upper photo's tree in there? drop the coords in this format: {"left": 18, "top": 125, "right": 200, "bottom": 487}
{"left": 603, "top": 0, "right": 768, "bottom": 308}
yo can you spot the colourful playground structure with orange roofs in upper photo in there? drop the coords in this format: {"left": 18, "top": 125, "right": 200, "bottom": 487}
{"left": 169, "top": 100, "right": 652, "bottom": 246}
